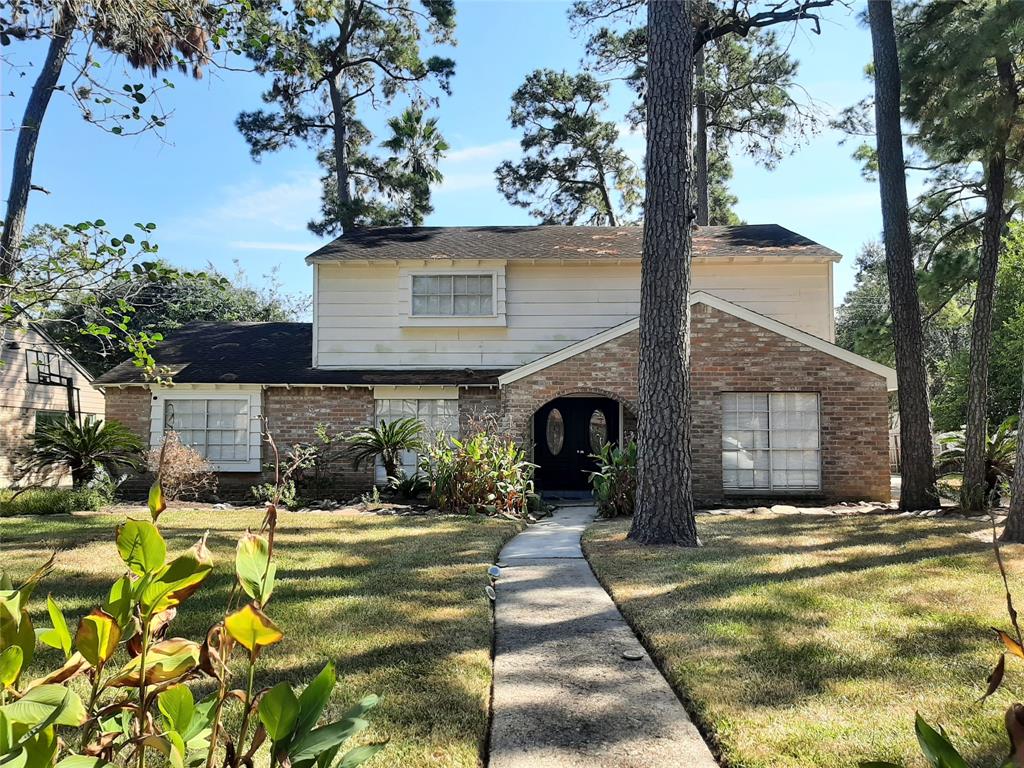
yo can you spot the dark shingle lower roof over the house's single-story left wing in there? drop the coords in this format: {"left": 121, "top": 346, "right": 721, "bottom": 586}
{"left": 94, "top": 323, "right": 505, "bottom": 386}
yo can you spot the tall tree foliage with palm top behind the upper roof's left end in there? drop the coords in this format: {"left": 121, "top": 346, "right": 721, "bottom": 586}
{"left": 237, "top": 0, "right": 455, "bottom": 234}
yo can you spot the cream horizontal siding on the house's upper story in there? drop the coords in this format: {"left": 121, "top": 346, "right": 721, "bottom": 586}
{"left": 316, "top": 262, "right": 833, "bottom": 368}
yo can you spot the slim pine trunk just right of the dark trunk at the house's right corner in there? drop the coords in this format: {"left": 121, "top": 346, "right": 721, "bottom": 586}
{"left": 961, "top": 153, "right": 1007, "bottom": 512}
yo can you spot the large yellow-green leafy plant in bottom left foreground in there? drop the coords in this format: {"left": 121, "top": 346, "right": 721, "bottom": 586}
{"left": 0, "top": 428, "right": 383, "bottom": 768}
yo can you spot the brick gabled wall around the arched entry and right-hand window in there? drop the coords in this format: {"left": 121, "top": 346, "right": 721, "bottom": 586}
{"left": 502, "top": 304, "right": 890, "bottom": 505}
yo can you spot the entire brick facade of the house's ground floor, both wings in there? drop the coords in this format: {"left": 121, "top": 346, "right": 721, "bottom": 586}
{"left": 106, "top": 304, "right": 890, "bottom": 505}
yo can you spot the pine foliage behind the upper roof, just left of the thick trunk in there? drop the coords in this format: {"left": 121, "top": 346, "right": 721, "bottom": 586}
{"left": 495, "top": 70, "right": 642, "bottom": 226}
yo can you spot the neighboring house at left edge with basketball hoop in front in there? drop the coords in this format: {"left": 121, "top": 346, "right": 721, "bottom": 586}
{"left": 0, "top": 324, "right": 103, "bottom": 487}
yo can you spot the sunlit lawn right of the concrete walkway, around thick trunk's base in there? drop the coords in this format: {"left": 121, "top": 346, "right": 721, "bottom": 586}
{"left": 584, "top": 515, "right": 1024, "bottom": 768}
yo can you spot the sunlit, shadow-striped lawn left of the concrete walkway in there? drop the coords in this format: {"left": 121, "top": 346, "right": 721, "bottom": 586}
{"left": 0, "top": 509, "right": 519, "bottom": 768}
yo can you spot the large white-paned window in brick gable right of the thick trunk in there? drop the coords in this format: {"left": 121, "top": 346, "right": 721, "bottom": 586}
{"left": 722, "top": 392, "right": 821, "bottom": 490}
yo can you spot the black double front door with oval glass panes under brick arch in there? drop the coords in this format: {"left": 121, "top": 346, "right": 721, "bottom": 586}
{"left": 534, "top": 397, "right": 618, "bottom": 492}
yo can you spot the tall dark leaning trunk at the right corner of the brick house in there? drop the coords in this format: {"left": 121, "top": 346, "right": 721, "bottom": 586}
{"left": 867, "top": 2, "right": 939, "bottom": 510}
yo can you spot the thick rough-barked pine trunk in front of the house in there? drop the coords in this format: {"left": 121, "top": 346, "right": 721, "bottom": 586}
{"left": 630, "top": 0, "right": 699, "bottom": 547}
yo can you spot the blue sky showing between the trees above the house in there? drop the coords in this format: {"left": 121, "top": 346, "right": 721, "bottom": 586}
{"left": 2, "top": 0, "right": 881, "bottom": 313}
